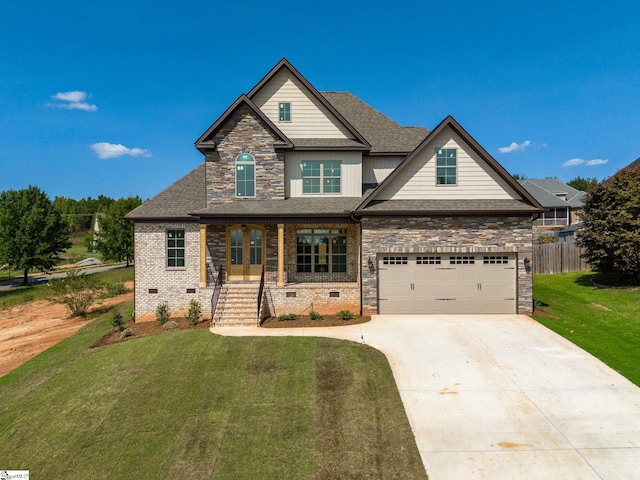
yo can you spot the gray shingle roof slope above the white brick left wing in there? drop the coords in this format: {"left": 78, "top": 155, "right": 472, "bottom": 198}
{"left": 125, "top": 163, "right": 207, "bottom": 221}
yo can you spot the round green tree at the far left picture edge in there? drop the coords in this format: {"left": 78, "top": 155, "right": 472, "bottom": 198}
{"left": 0, "top": 186, "right": 71, "bottom": 285}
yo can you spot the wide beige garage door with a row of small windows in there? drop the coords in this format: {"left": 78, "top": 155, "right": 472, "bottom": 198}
{"left": 378, "top": 253, "right": 517, "bottom": 314}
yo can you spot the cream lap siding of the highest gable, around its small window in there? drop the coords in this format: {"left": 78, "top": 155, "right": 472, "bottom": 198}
{"left": 252, "top": 69, "right": 352, "bottom": 138}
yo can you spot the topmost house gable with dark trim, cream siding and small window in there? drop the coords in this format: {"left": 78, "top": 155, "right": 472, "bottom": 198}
{"left": 247, "top": 58, "right": 371, "bottom": 150}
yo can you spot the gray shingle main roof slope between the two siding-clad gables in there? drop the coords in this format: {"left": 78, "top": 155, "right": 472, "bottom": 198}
{"left": 322, "top": 92, "right": 429, "bottom": 154}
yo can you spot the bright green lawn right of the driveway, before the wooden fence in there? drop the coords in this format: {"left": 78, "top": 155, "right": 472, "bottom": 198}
{"left": 533, "top": 272, "right": 640, "bottom": 386}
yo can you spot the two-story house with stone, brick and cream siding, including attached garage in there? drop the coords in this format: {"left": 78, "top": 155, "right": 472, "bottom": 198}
{"left": 127, "top": 59, "right": 543, "bottom": 325}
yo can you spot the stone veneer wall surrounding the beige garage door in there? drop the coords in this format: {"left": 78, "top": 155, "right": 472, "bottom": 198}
{"left": 362, "top": 216, "right": 533, "bottom": 315}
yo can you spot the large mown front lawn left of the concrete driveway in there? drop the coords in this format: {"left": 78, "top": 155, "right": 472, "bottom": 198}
{"left": 0, "top": 304, "right": 427, "bottom": 480}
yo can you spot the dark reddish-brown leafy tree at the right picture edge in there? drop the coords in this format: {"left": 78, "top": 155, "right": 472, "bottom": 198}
{"left": 577, "top": 167, "right": 640, "bottom": 283}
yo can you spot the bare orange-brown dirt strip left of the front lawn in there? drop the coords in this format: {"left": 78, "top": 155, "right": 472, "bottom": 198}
{"left": 0, "top": 282, "right": 133, "bottom": 377}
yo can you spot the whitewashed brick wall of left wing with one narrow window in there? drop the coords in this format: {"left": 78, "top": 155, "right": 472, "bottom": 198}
{"left": 134, "top": 223, "right": 213, "bottom": 322}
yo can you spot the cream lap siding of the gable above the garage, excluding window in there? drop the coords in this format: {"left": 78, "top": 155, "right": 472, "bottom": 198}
{"left": 377, "top": 128, "right": 521, "bottom": 200}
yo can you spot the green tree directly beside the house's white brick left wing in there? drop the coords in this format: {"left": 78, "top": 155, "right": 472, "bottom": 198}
{"left": 95, "top": 197, "right": 142, "bottom": 267}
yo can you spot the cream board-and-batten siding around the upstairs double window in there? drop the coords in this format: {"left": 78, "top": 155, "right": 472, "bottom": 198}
{"left": 285, "top": 151, "right": 362, "bottom": 197}
